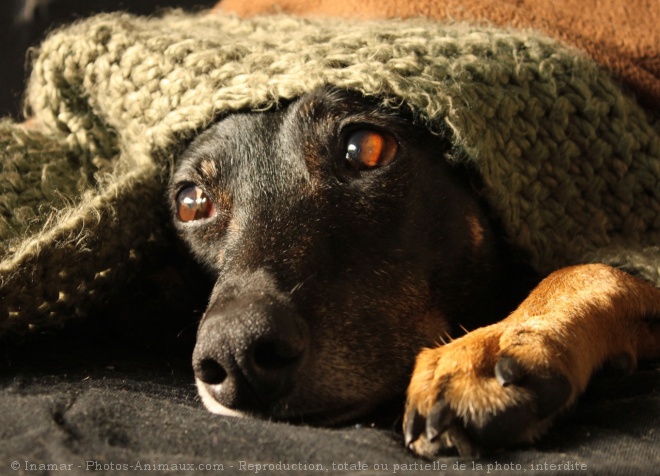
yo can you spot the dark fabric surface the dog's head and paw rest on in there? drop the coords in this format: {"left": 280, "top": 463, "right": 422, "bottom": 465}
{"left": 0, "top": 304, "right": 660, "bottom": 475}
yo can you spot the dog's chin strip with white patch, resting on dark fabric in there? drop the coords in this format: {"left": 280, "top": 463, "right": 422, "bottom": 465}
{"left": 196, "top": 380, "right": 373, "bottom": 426}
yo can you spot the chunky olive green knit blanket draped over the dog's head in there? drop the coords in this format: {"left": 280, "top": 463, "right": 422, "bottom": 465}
{"left": 0, "top": 12, "right": 660, "bottom": 333}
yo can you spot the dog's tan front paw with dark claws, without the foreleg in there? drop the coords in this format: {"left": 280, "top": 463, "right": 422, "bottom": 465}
{"left": 404, "top": 323, "right": 576, "bottom": 457}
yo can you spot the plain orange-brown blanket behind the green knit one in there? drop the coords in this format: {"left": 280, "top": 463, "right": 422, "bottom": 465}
{"left": 216, "top": 0, "right": 660, "bottom": 109}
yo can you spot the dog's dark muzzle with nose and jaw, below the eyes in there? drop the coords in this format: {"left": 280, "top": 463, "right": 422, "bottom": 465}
{"left": 193, "top": 271, "right": 403, "bottom": 426}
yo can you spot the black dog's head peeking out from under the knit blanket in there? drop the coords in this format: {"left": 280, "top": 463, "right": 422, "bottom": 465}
{"left": 171, "top": 90, "right": 510, "bottom": 423}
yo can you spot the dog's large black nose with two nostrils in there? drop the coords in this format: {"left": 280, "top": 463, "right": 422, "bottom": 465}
{"left": 193, "top": 286, "right": 308, "bottom": 413}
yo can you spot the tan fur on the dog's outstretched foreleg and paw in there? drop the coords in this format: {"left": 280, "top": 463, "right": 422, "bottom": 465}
{"left": 408, "top": 264, "right": 660, "bottom": 450}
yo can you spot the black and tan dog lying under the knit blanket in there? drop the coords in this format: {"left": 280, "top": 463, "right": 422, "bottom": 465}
{"left": 169, "top": 89, "right": 660, "bottom": 457}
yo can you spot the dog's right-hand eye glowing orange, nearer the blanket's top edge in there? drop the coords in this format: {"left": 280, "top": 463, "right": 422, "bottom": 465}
{"left": 346, "top": 129, "right": 398, "bottom": 170}
